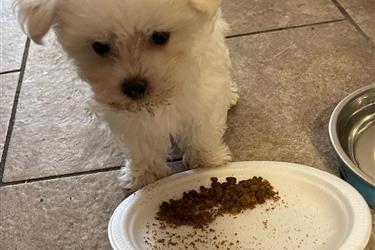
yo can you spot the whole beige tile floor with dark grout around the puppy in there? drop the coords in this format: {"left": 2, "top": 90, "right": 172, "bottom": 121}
{"left": 0, "top": 0, "right": 375, "bottom": 249}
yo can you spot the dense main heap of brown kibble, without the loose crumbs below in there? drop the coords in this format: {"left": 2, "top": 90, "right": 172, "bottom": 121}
{"left": 156, "top": 177, "right": 278, "bottom": 229}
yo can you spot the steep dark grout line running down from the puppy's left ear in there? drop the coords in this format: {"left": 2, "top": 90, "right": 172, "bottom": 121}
{"left": 0, "top": 38, "right": 30, "bottom": 186}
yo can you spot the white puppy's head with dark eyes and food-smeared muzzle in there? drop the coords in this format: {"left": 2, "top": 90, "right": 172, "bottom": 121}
{"left": 15, "top": 0, "right": 220, "bottom": 111}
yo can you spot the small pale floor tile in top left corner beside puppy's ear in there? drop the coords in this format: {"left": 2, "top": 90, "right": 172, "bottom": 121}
{"left": 0, "top": 0, "right": 26, "bottom": 72}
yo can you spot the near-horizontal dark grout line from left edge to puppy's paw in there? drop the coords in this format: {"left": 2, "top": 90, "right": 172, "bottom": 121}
{"left": 0, "top": 166, "right": 121, "bottom": 187}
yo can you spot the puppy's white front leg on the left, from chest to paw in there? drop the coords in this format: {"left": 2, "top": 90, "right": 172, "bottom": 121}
{"left": 87, "top": 100, "right": 171, "bottom": 190}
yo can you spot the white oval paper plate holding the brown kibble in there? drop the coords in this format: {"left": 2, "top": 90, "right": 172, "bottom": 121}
{"left": 108, "top": 162, "right": 371, "bottom": 250}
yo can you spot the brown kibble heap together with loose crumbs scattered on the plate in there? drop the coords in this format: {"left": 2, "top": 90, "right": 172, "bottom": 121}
{"left": 147, "top": 177, "right": 280, "bottom": 250}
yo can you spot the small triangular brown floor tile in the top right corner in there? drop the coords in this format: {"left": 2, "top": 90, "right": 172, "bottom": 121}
{"left": 338, "top": 0, "right": 375, "bottom": 43}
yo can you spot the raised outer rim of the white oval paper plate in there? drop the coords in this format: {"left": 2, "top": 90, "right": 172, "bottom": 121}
{"left": 107, "top": 161, "right": 372, "bottom": 250}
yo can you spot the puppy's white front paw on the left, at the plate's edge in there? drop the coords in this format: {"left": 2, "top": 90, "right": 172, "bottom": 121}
{"left": 119, "top": 162, "right": 170, "bottom": 191}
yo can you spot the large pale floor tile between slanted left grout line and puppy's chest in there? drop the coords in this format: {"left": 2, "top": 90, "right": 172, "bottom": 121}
{"left": 3, "top": 33, "right": 123, "bottom": 182}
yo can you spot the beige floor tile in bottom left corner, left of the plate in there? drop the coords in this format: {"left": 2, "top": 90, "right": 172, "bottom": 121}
{"left": 0, "top": 171, "right": 126, "bottom": 250}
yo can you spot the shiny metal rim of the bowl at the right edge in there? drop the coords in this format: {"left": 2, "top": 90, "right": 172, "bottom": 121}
{"left": 329, "top": 84, "right": 375, "bottom": 187}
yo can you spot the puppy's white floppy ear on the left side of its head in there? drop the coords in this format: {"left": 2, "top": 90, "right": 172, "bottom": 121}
{"left": 13, "top": 0, "right": 58, "bottom": 44}
